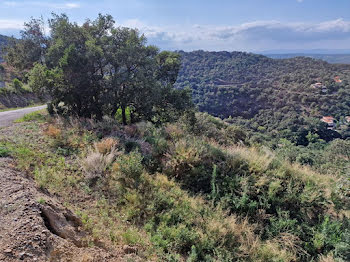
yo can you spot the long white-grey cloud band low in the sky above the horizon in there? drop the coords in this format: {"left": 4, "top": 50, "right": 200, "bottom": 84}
{"left": 0, "top": 14, "right": 350, "bottom": 51}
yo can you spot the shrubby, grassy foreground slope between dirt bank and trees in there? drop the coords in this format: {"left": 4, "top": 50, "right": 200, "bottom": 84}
{"left": 0, "top": 113, "right": 350, "bottom": 261}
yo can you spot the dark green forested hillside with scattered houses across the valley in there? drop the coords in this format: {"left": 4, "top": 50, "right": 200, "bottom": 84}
{"left": 176, "top": 51, "right": 350, "bottom": 144}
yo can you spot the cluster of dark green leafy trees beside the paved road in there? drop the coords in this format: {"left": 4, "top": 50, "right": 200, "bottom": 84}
{"left": 6, "top": 14, "right": 192, "bottom": 124}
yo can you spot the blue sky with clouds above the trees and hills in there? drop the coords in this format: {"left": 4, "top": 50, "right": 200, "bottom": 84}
{"left": 0, "top": 0, "right": 350, "bottom": 52}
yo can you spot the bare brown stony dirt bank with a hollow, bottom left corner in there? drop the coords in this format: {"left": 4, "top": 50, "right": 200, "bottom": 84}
{"left": 0, "top": 158, "right": 136, "bottom": 262}
